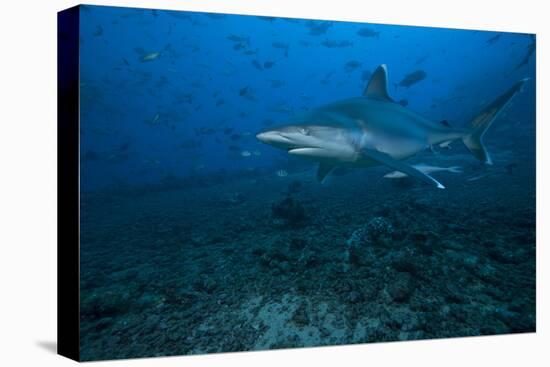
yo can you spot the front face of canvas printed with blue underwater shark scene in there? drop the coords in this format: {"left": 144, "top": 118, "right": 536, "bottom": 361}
{"left": 75, "top": 6, "right": 536, "bottom": 360}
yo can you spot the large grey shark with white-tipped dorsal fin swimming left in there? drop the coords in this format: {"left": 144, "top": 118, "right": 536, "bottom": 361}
{"left": 256, "top": 64, "right": 529, "bottom": 189}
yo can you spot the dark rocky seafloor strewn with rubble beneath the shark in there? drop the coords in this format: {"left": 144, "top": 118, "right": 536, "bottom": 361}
{"left": 80, "top": 159, "right": 535, "bottom": 360}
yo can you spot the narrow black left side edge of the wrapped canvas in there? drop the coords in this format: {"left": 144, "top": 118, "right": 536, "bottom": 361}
{"left": 57, "top": 6, "right": 80, "bottom": 360}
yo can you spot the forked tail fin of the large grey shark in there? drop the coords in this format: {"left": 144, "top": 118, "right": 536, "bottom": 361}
{"left": 462, "top": 78, "right": 529, "bottom": 164}
